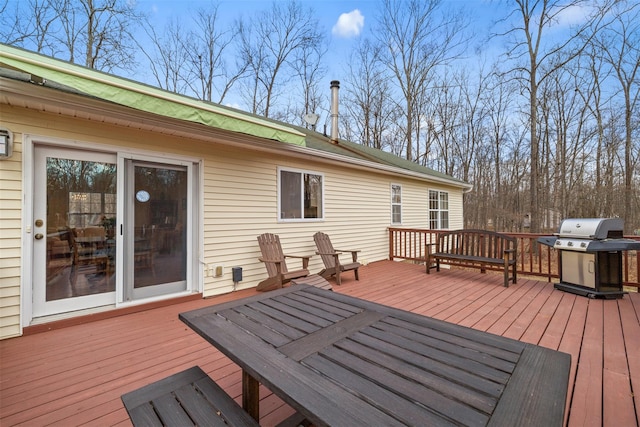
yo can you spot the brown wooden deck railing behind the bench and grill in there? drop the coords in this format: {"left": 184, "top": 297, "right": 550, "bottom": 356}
{"left": 389, "top": 227, "right": 640, "bottom": 290}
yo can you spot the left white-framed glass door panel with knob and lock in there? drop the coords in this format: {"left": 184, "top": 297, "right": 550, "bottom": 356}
{"left": 32, "top": 147, "right": 117, "bottom": 316}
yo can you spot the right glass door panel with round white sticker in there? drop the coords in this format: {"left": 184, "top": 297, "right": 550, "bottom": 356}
{"left": 124, "top": 160, "right": 189, "bottom": 300}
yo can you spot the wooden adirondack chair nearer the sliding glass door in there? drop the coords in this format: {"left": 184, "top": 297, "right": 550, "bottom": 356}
{"left": 256, "top": 233, "right": 311, "bottom": 291}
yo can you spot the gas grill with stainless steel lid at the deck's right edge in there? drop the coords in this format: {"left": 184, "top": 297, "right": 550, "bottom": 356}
{"left": 538, "top": 218, "right": 640, "bottom": 298}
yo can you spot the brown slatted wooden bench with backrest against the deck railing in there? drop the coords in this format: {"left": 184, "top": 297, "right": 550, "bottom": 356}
{"left": 426, "top": 230, "right": 518, "bottom": 287}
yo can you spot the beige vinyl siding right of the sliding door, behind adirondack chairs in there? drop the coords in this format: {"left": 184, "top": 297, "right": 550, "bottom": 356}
{"left": 198, "top": 152, "right": 462, "bottom": 295}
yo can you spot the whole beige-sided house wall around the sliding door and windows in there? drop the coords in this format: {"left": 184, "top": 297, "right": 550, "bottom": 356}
{"left": 0, "top": 105, "right": 462, "bottom": 338}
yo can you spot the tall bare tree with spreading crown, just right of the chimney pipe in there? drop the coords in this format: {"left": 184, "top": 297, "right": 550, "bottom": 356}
{"left": 376, "top": 0, "right": 465, "bottom": 160}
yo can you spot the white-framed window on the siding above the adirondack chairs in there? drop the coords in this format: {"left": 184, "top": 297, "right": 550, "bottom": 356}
{"left": 279, "top": 169, "right": 324, "bottom": 221}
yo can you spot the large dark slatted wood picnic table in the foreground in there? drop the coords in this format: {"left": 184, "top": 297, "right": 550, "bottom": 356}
{"left": 180, "top": 285, "right": 570, "bottom": 426}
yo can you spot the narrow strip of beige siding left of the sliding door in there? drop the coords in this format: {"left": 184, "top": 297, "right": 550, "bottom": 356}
{"left": 0, "top": 129, "right": 22, "bottom": 338}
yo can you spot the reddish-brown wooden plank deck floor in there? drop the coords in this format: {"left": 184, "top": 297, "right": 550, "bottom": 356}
{"left": 0, "top": 261, "right": 640, "bottom": 427}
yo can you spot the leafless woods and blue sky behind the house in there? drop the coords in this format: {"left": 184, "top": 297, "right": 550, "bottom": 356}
{"left": 0, "top": 0, "right": 640, "bottom": 234}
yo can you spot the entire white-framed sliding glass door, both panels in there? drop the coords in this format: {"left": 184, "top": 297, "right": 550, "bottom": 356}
{"left": 29, "top": 144, "right": 198, "bottom": 317}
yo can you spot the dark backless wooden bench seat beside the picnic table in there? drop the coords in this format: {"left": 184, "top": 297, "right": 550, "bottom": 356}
{"left": 122, "top": 366, "right": 259, "bottom": 427}
